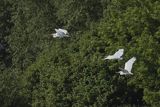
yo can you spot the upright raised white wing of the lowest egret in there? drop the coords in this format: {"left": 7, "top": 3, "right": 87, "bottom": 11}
{"left": 124, "top": 57, "right": 136, "bottom": 73}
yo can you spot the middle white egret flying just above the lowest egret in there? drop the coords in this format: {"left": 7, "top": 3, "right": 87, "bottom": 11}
{"left": 104, "top": 49, "right": 124, "bottom": 60}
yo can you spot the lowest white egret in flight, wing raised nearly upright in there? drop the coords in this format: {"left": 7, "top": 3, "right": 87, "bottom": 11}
{"left": 117, "top": 57, "right": 136, "bottom": 75}
